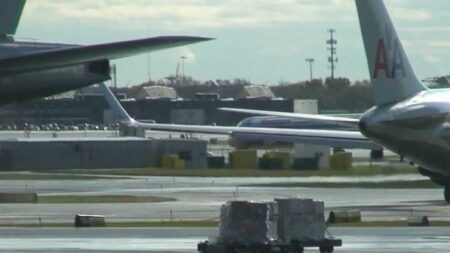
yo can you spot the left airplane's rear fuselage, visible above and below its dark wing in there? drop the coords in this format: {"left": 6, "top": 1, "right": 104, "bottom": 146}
{"left": 0, "top": 40, "right": 110, "bottom": 105}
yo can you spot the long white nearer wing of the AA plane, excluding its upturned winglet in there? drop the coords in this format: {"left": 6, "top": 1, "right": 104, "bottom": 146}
{"left": 139, "top": 122, "right": 381, "bottom": 150}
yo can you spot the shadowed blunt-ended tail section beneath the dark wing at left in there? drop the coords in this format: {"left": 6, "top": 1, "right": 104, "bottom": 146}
{"left": 0, "top": 60, "right": 110, "bottom": 105}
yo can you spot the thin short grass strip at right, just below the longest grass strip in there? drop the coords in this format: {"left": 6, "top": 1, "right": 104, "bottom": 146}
{"left": 247, "top": 180, "right": 442, "bottom": 189}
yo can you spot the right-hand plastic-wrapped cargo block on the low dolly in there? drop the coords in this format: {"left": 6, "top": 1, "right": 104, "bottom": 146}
{"left": 275, "top": 199, "right": 326, "bottom": 241}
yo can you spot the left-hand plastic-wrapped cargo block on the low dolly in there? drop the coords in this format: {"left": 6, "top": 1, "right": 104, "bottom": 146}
{"left": 218, "top": 201, "right": 276, "bottom": 243}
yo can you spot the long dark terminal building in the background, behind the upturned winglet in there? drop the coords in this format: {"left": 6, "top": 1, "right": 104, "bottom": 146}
{"left": 0, "top": 86, "right": 306, "bottom": 129}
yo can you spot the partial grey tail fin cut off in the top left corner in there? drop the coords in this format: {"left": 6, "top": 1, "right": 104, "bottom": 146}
{"left": 0, "top": 0, "right": 26, "bottom": 36}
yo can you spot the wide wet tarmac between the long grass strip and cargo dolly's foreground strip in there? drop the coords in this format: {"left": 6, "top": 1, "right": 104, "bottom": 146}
{"left": 0, "top": 175, "right": 444, "bottom": 223}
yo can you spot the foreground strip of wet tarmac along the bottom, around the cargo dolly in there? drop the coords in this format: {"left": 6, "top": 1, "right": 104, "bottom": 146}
{"left": 0, "top": 227, "right": 450, "bottom": 253}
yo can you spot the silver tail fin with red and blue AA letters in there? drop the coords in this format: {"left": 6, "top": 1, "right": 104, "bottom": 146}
{"left": 355, "top": 0, "right": 427, "bottom": 105}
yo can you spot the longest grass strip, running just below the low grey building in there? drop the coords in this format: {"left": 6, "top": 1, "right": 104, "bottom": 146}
{"left": 37, "top": 165, "right": 418, "bottom": 177}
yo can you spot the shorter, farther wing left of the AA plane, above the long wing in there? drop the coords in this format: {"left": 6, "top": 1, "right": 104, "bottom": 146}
{"left": 219, "top": 107, "right": 359, "bottom": 127}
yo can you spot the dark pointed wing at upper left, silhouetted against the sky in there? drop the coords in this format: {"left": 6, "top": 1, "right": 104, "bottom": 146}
{"left": 0, "top": 36, "right": 211, "bottom": 74}
